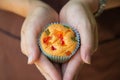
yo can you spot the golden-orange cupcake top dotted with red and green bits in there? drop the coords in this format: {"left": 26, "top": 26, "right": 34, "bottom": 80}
{"left": 39, "top": 24, "right": 77, "bottom": 56}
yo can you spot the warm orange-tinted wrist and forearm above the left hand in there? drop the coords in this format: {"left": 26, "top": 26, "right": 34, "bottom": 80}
{"left": 0, "top": 0, "right": 49, "bottom": 17}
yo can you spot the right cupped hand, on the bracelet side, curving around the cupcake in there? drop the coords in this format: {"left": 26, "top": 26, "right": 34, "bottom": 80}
{"left": 60, "top": 0, "right": 98, "bottom": 80}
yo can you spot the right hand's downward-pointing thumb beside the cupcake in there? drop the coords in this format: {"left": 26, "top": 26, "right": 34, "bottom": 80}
{"left": 79, "top": 17, "right": 98, "bottom": 64}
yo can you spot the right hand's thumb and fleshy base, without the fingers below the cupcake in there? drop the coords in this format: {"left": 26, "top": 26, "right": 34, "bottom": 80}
{"left": 60, "top": 4, "right": 98, "bottom": 64}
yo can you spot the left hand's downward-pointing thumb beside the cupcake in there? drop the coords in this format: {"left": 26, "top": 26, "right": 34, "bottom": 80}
{"left": 21, "top": 27, "right": 40, "bottom": 64}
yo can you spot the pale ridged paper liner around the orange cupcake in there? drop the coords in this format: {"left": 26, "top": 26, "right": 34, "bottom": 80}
{"left": 38, "top": 23, "right": 81, "bottom": 63}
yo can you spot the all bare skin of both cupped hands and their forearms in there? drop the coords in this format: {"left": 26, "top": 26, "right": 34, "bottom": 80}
{"left": 0, "top": 0, "right": 120, "bottom": 80}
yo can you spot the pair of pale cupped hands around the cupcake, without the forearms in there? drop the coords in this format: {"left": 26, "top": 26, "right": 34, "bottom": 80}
{"left": 21, "top": 1, "right": 98, "bottom": 80}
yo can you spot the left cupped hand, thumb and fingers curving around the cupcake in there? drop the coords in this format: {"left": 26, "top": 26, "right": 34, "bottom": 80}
{"left": 21, "top": 6, "right": 61, "bottom": 80}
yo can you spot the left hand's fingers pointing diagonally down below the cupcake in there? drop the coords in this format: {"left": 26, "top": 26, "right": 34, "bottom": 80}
{"left": 35, "top": 54, "right": 61, "bottom": 80}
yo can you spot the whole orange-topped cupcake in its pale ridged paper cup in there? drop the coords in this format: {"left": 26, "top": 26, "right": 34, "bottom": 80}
{"left": 38, "top": 23, "right": 80, "bottom": 63}
